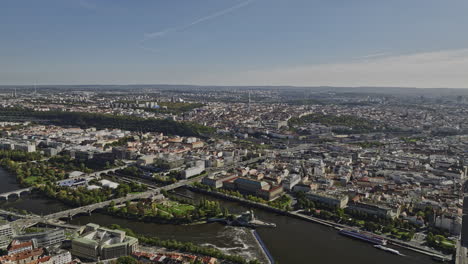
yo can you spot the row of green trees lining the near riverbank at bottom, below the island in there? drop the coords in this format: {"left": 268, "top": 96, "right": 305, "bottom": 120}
{"left": 110, "top": 224, "right": 260, "bottom": 264}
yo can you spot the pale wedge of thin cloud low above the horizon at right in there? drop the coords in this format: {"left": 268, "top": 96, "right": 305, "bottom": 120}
{"left": 203, "top": 49, "right": 468, "bottom": 88}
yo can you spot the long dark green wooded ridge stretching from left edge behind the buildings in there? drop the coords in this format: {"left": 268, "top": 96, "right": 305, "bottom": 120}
{"left": 0, "top": 108, "right": 214, "bottom": 136}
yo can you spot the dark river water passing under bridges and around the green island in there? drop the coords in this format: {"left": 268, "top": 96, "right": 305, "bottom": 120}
{"left": 0, "top": 169, "right": 437, "bottom": 264}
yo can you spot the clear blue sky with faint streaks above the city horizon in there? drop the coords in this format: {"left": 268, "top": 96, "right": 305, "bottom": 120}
{"left": 0, "top": 0, "right": 468, "bottom": 88}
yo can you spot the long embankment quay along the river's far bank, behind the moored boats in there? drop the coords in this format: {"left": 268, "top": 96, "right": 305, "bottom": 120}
{"left": 184, "top": 186, "right": 452, "bottom": 260}
